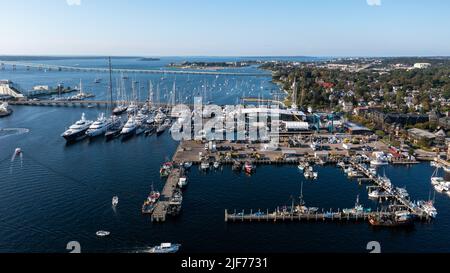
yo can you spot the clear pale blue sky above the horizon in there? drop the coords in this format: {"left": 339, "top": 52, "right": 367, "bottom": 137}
{"left": 0, "top": 0, "right": 450, "bottom": 56}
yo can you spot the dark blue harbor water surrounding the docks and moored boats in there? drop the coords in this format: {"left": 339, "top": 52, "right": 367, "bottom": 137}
{"left": 0, "top": 58, "right": 450, "bottom": 253}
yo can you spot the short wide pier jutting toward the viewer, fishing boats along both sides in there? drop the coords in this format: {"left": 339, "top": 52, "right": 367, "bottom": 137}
{"left": 151, "top": 168, "right": 181, "bottom": 222}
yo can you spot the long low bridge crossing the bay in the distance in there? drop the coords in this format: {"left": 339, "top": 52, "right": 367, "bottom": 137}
{"left": 0, "top": 61, "right": 271, "bottom": 77}
